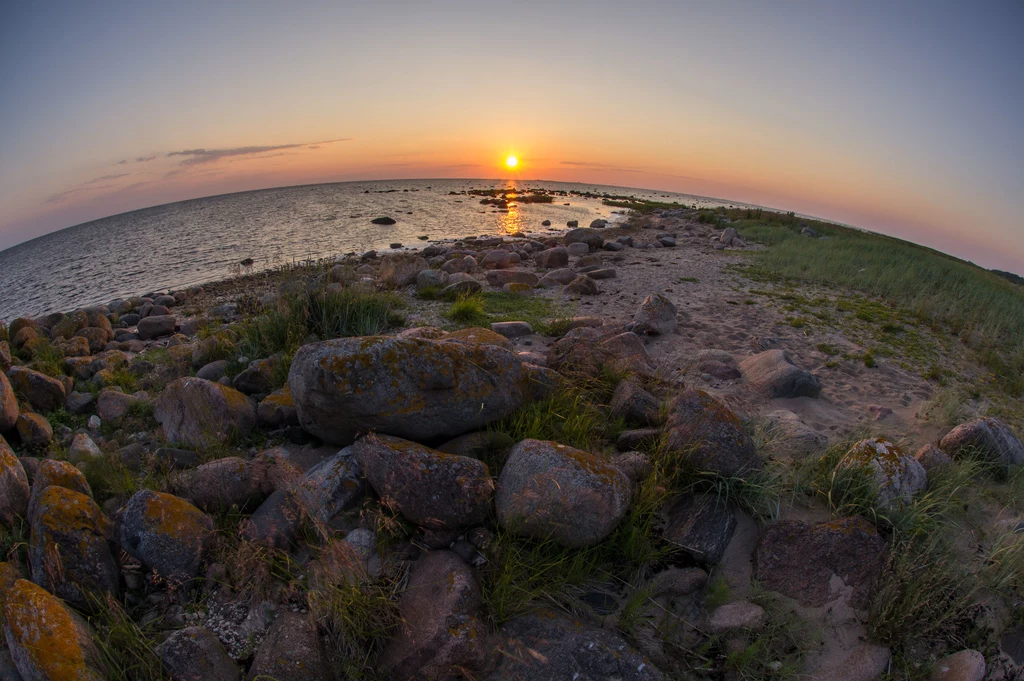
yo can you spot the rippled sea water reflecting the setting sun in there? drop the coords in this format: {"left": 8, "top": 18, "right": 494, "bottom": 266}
{"left": 0, "top": 180, "right": 714, "bottom": 321}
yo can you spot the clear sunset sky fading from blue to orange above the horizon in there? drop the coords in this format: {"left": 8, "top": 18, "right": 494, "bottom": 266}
{"left": 0, "top": 0, "right": 1024, "bottom": 273}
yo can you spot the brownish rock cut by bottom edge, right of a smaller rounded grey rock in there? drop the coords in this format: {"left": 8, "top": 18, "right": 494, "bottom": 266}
{"left": 246, "top": 612, "right": 334, "bottom": 681}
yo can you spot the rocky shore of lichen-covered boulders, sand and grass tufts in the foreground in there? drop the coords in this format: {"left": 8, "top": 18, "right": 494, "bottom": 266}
{"left": 0, "top": 209, "right": 1024, "bottom": 681}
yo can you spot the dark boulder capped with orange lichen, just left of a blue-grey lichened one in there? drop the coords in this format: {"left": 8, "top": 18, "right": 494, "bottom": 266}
{"left": 29, "top": 485, "right": 121, "bottom": 608}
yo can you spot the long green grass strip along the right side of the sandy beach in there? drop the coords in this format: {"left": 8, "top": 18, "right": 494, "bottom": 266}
{"left": 734, "top": 214, "right": 1024, "bottom": 395}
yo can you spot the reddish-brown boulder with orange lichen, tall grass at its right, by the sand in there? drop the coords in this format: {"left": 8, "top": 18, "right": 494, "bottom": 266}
{"left": 667, "top": 390, "right": 762, "bottom": 477}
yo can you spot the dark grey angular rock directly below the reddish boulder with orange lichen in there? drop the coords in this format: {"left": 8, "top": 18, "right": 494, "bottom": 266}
{"left": 662, "top": 495, "right": 736, "bottom": 565}
